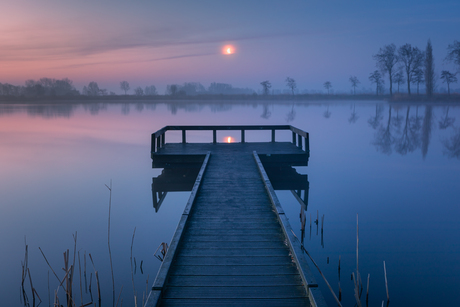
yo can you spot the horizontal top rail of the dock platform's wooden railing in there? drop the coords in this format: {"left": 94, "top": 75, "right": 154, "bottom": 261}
{"left": 153, "top": 125, "right": 308, "bottom": 138}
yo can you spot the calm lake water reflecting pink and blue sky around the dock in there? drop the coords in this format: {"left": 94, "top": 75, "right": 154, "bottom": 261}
{"left": 0, "top": 101, "right": 460, "bottom": 306}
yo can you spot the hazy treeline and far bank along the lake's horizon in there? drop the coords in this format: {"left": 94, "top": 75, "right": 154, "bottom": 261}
{"left": 0, "top": 40, "right": 460, "bottom": 101}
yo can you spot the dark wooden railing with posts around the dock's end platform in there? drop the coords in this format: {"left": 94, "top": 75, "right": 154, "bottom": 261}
{"left": 151, "top": 125, "right": 310, "bottom": 154}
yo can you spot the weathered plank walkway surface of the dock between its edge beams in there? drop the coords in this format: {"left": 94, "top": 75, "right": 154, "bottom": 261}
{"left": 155, "top": 144, "right": 309, "bottom": 306}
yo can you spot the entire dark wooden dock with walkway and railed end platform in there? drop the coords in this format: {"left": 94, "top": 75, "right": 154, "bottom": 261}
{"left": 146, "top": 126, "right": 326, "bottom": 306}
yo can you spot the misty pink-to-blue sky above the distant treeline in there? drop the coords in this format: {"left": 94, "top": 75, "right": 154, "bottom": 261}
{"left": 0, "top": 0, "right": 460, "bottom": 94}
